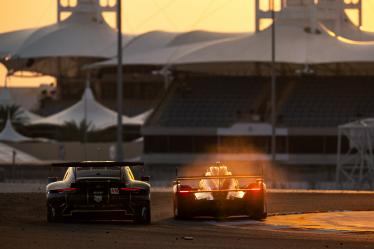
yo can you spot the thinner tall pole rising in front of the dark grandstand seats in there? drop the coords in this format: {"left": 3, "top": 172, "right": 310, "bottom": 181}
{"left": 271, "top": 0, "right": 277, "bottom": 165}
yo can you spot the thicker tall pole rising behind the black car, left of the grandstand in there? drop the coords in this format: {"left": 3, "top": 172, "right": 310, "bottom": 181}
{"left": 116, "top": 0, "right": 123, "bottom": 162}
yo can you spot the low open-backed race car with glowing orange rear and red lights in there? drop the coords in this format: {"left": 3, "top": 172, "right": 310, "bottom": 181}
{"left": 173, "top": 162, "right": 267, "bottom": 220}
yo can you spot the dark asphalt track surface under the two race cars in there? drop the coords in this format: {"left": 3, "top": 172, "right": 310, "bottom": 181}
{"left": 0, "top": 193, "right": 374, "bottom": 249}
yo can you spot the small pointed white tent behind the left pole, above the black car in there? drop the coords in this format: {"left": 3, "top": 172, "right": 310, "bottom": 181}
{"left": 30, "top": 87, "right": 149, "bottom": 130}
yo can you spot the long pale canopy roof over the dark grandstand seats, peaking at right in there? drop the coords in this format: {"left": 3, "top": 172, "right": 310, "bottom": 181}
{"left": 88, "top": 1, "right": 374, "bottom": 68}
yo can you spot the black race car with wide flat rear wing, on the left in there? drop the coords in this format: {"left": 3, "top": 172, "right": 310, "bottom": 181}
{"left": 46, "top": 161, "right": 151, "bottom": 224}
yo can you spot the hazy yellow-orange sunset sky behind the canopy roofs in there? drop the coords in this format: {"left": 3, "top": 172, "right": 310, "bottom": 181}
{"left": 0, "top": 0, "right": 374, "bottom": 86}
